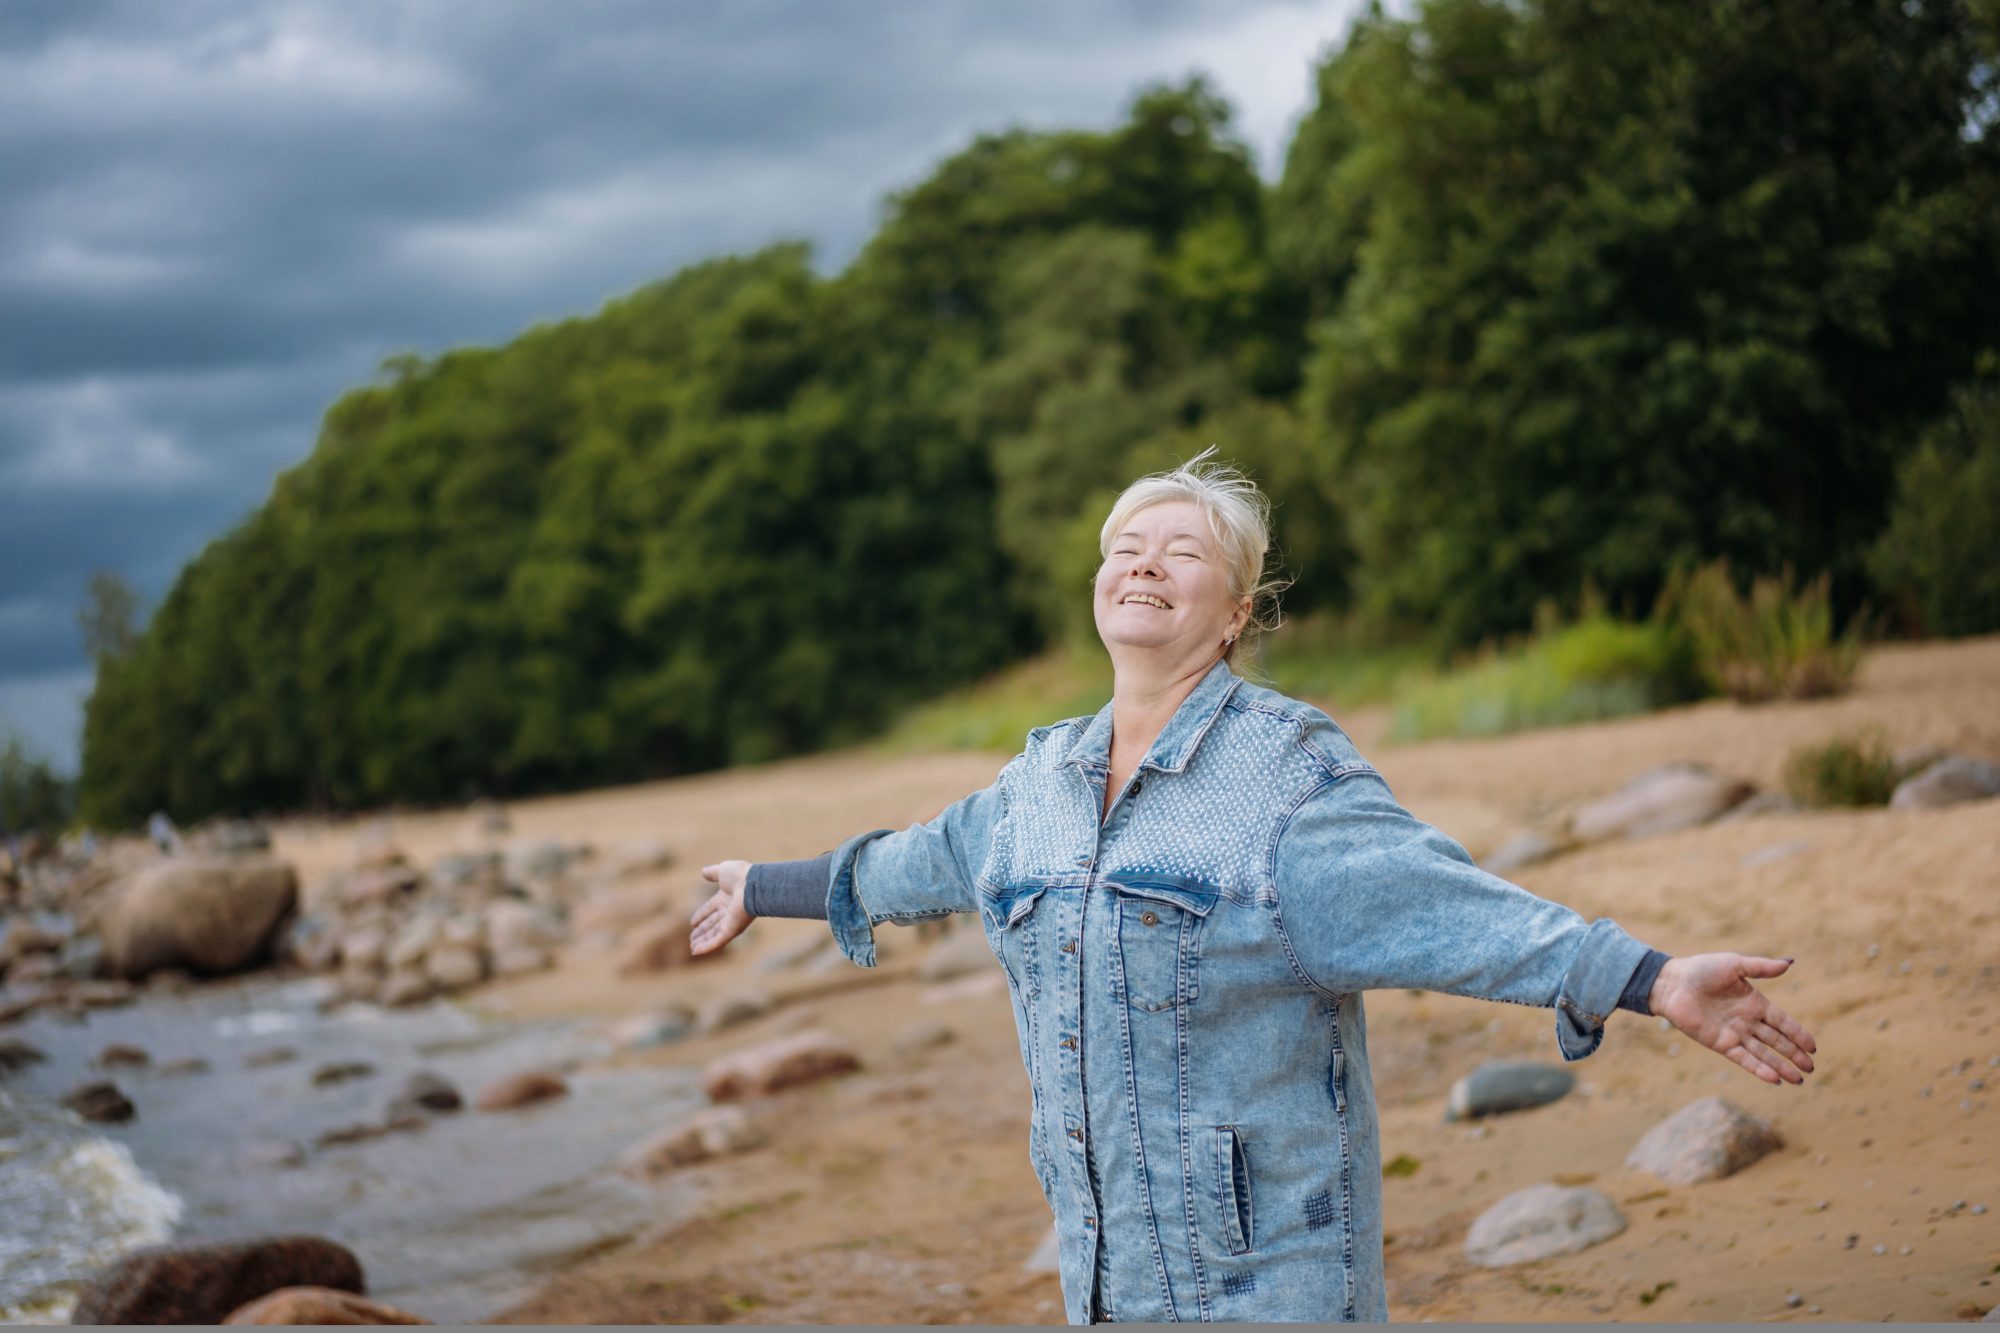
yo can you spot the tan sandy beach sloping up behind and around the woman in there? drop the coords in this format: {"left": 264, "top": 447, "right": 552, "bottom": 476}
{"left": 280, "top": 638, "right": 2000, "bottom": 1323}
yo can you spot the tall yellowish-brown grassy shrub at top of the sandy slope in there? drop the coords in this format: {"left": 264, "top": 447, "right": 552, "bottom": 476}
{"left": 1662, "top": 560, "right": 1866, "bottom": 703}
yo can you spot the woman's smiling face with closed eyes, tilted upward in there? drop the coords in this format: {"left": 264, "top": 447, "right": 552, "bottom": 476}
{"left": 1094, "top": 500, "right": 1250, "bottom": 658}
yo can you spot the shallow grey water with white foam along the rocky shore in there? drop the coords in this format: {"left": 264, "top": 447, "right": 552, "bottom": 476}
{"left": 0, "top": 979, "right": 702, "bottom": 1323}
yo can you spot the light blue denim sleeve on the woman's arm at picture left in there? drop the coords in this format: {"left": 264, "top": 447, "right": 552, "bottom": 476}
{"left": 826, "top": 775, "right": 1006, "bottom": 967}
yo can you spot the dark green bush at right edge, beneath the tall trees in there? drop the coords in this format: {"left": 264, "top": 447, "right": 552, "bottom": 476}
{"left": 1868, "top": 384, "right": 2000, "bottom": 634}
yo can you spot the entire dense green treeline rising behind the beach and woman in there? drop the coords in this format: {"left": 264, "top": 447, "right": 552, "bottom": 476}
{"left": 82, "top": 0, "right": 2000, "bottom": 823}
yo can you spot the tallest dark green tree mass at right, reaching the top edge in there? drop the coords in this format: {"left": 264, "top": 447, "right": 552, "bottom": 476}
{"left": 1292, "top": 0, "right": 2000, "bottom": 642}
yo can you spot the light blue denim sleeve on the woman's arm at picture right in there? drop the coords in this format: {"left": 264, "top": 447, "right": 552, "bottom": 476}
{"left": 1272, "top": 767, "right": 1648, "bottom": 1061}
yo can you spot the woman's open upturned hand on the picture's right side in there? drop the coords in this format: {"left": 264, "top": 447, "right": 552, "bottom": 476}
{"left": 1648, "top": 953, "right": 1818, "bottom": 1083}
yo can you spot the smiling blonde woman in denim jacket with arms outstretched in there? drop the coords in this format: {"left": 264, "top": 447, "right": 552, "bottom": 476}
{"left": 692, "top": 454, "right": 1814, "bottom": 1323}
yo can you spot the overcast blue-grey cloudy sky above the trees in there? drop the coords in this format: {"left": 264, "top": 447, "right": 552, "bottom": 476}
{"left": 0, "top": 0, "right": 1358, "bottom": 769}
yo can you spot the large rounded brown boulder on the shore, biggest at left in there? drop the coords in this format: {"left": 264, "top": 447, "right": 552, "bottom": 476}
{"left": 98, "top": 857, "right": 298, "bottom": 981}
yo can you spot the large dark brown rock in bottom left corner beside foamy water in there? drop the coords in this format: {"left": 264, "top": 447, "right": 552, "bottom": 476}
{"left": 70, "top": 1235, "right": 368, "bottom": 1323}
